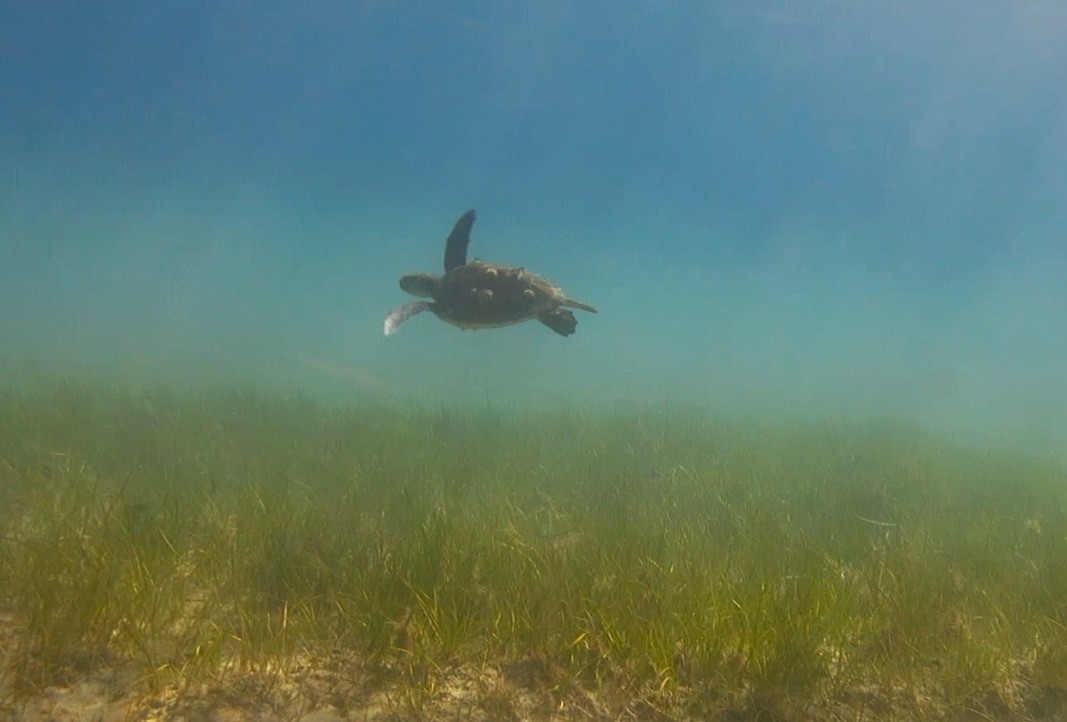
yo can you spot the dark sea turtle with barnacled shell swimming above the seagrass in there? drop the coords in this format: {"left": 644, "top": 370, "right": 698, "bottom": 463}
{"left": 384, "top": 209, "right": 596, "bottom": 336}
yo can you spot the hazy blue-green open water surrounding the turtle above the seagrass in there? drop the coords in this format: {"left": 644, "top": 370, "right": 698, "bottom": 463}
{"left": 0, "top": 5, "right": 1067, "bottom": 450}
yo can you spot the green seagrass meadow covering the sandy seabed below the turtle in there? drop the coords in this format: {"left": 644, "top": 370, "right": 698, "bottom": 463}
{"left": 0, "top": 382, "right": 1067, "bottom": 720}
